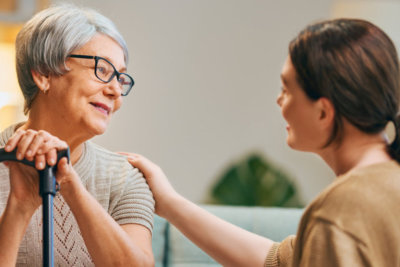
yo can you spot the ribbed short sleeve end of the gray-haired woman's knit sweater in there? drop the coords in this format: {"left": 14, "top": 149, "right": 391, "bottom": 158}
{"left": 111, "top": 166, "right": 155, "bottom": 232}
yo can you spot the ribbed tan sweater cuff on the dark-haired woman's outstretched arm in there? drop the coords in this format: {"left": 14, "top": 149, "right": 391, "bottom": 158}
{"left": 265, "top": 235, "right": 296, "bottom": 267}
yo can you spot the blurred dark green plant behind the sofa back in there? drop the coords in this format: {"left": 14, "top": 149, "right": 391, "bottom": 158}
{"left": 210, "top": 153, "right": 303, "bottom": 207}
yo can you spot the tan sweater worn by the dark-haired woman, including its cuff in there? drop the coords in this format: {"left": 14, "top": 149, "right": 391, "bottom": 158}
{"left": 265, "top": 160, "right": 400, "bottom": 267}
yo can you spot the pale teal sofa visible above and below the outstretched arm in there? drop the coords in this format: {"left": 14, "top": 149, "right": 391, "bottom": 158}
{"left": 153, "top": 205, "right": 303, "bottom": 267}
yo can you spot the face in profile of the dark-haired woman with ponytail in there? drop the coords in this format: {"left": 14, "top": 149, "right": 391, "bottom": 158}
{"left": 277, "top": 57, "right": 326, "bottom": 152}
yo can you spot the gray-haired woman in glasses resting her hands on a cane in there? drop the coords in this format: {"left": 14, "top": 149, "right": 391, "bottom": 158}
{"left": 0, "top": 5, "right": 154, "bottom": 266}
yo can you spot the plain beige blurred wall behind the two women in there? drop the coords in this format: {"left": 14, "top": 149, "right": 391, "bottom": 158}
{"left": 0, "top": 0, "right": 400, "bottom": 203}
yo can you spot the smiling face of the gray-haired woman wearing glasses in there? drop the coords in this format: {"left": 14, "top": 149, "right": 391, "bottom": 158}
{"left": 49, "top": 34, "right": 126, "bottom": 136}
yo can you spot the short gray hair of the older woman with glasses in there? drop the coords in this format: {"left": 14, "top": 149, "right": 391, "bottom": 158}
{"left": 16, "top": 4, "right": 128, "bottom": 114}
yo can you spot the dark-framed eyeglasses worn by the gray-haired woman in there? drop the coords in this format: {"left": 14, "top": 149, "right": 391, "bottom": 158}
{"left": 68, "top": 55, "right": 135, "bottom": 96}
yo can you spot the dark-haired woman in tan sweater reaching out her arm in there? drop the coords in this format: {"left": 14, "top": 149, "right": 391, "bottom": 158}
{"left": 124, "top": 19, "right": 400, "bottom": 267}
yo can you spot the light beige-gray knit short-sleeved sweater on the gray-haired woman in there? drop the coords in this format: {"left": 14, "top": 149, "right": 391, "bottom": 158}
{"left": 0, "top": 125, "right": 154, "bottom": 266}
